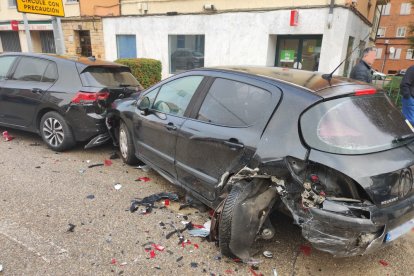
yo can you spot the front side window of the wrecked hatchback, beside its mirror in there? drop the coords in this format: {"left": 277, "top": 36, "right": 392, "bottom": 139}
{"left": 153, "top": 76, "right": 203, "bottom": 116}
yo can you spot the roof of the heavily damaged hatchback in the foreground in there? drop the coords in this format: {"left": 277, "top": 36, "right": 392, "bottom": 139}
{"left": 202, "top": 66, "right": 366, "bottom": 96}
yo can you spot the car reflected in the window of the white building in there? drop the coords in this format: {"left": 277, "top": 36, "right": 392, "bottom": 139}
{"left": 171, "top": 48, "right": 204, "bottom": 72}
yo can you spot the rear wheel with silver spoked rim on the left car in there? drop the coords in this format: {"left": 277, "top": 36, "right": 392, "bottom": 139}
{"left": 39, "top": 111, "right": 76, "bottom": 151}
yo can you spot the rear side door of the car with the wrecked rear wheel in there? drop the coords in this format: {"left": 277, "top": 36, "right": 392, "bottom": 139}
{"left": 176, "top": 75, "right": 281, "bottom": 201}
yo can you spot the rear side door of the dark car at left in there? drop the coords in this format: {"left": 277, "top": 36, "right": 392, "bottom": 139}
{"left": 1, "top": 57, "right": 57, "bottom": 127}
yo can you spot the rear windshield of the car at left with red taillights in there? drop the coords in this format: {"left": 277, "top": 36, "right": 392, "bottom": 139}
{"left": 80, "top": 66, "right": 139, "bottom": 87}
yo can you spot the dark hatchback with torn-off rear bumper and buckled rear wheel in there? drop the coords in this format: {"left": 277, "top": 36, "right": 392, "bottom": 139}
{"left": 109, "top": 67, "right": 414, "bottom": 260}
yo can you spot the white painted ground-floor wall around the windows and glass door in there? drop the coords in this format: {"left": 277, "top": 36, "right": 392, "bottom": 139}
{"left": 103, "top": 8, "right": 369, "bottom": 78}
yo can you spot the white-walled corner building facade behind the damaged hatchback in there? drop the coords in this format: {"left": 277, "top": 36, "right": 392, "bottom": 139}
{"left": 103, "top": 0, "right": 387, "bottom": 77}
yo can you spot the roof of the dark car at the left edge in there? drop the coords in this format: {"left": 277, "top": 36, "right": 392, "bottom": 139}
{"left": 1, "top": 52, "right": 126, "bottom": 67}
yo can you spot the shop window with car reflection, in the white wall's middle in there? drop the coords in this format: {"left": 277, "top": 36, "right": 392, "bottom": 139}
{"left": 168, "top": 35, "right": 205, "bottom": 74}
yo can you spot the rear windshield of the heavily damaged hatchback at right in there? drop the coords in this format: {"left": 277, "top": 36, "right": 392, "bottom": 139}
{"left": 300, "top": 93, "right": 413, "bottom": 154}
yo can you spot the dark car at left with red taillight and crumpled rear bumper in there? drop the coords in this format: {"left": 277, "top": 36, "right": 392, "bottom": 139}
{"left": 0, "top": 53, "right": 139, "bottom": 151}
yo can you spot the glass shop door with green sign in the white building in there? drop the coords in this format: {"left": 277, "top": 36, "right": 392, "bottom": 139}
{"left": 275, "top": 35, "right": 322, "bottom": 71}
